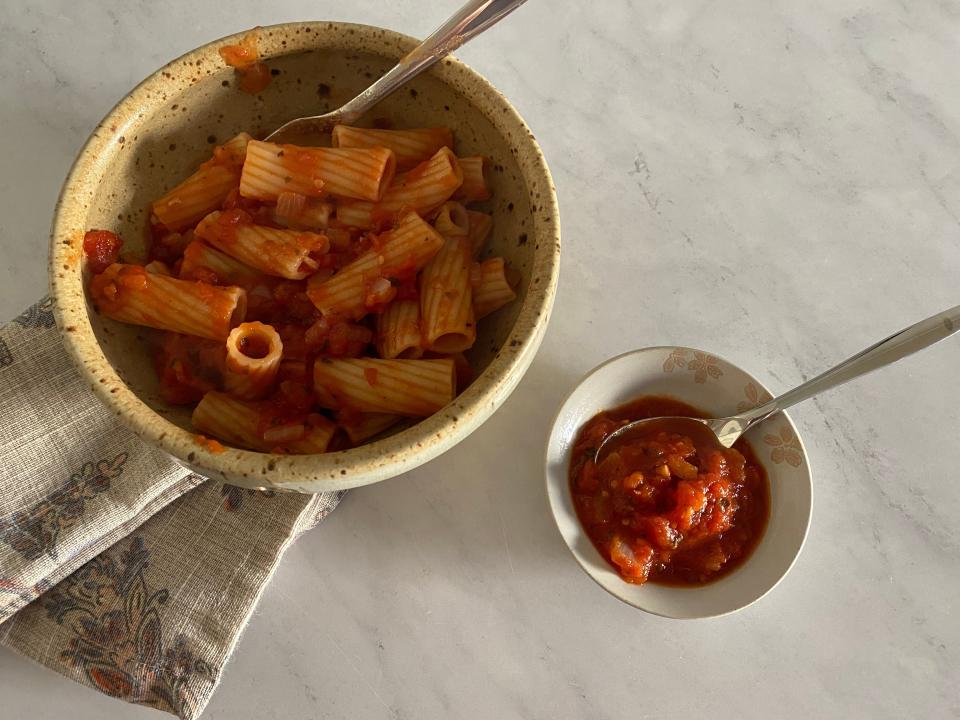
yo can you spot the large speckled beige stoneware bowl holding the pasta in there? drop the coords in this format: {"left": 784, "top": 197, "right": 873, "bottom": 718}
{"left": 50, "top": 22, "right": 560, "bottom": 493}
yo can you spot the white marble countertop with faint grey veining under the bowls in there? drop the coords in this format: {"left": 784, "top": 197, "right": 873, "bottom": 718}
{"left": 0, "top": 0, "right": 960, "bottom": 720}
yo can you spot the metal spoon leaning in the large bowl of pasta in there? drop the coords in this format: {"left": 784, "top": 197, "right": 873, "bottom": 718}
{"left": 266, "top": 0, "right": 526, "bottom": 142}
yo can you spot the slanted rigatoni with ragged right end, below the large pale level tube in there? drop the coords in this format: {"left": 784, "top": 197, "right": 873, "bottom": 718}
{"left": 195, "top": 210, "right": 330, "bottom": 280}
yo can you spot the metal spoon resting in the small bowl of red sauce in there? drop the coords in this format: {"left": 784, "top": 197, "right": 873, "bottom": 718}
{"left": 594, "top": 305, "right": 960, "bottom": 463}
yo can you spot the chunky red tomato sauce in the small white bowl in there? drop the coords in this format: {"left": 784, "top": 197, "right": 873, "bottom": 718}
{"left": 570, "top": 396, "right": 770, "bottom": 585}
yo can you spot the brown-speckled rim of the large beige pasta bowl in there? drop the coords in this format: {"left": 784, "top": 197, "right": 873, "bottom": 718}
{"left": 48, "top": 21, "right": 560, "bottom": 493}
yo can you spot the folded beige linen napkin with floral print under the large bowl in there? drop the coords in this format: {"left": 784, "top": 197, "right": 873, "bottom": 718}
{"left": 0, "top": 298, "right": 342, "bottom": 719}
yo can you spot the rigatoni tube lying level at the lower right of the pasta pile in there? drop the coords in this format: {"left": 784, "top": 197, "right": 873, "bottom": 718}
{"left": 313, "top": 358, "right": 456, "bottom": 417}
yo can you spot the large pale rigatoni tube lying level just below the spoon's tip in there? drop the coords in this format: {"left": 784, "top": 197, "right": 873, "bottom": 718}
{"left": 240, "top": 140, "right": 397, "bottom": 201}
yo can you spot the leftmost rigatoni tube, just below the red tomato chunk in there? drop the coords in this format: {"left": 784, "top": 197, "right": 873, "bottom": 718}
{"left": 90, "top": 263, "right": 247, "bottom": 341}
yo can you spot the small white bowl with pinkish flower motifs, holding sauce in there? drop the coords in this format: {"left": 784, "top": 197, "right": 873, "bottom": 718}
{"left": 546, "top": 347, "right": 813, "bottom": 618}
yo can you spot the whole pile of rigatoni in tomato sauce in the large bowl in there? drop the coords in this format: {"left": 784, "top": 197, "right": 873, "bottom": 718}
{"left": 84, "top": 120, "right": 516, "bottom": 453}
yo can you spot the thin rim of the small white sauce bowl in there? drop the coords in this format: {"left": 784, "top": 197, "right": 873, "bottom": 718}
{"left": 544, "top": 345, "right": 814, "bottom": 620}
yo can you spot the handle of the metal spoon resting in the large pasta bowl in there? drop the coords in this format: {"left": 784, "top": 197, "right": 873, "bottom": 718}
{"left": 332, "top": 0, "right": 526, "bottom": 125}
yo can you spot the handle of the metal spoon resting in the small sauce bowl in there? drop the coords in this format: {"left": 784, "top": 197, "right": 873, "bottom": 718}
{"left": 739, "top": 305, "right": 960, "bottom": 425}
